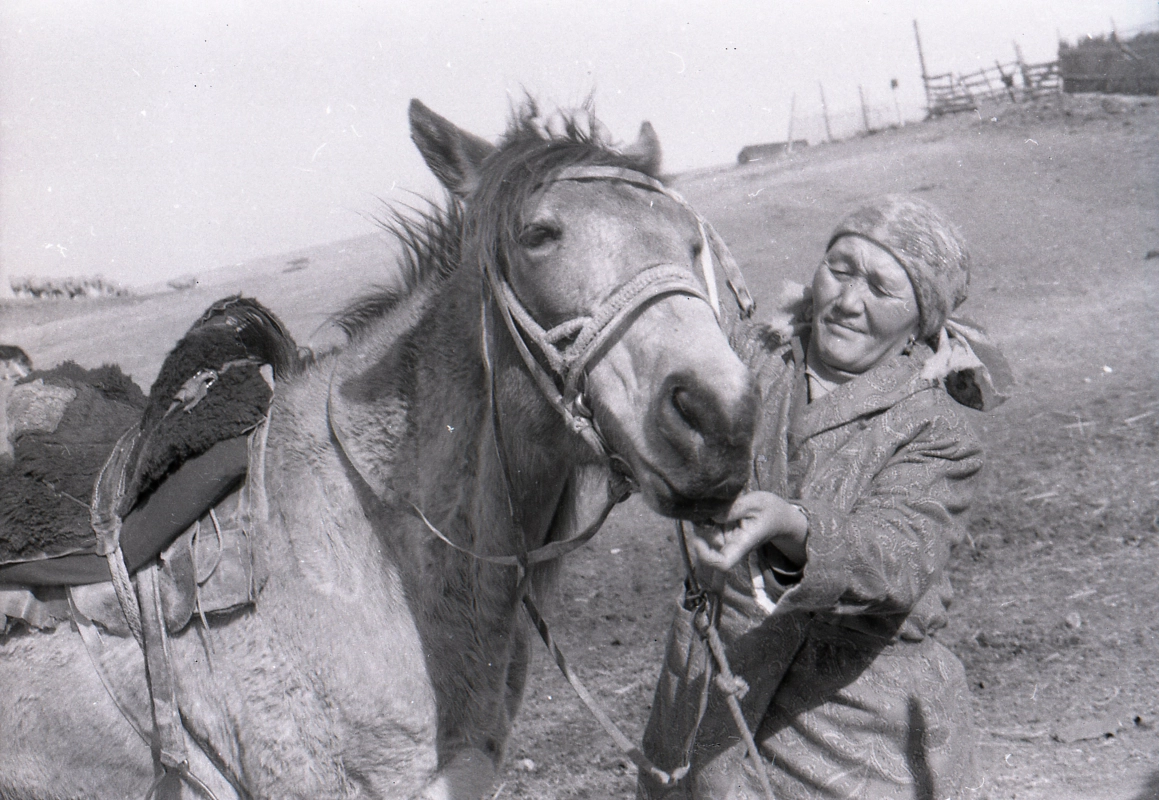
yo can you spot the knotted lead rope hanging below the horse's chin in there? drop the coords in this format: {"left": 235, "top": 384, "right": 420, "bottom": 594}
{"left": 676, "top": 519, "right": 777, "bottom": 800}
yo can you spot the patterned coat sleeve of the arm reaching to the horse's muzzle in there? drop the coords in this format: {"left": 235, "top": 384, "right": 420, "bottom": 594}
{"left": 778, "top": 402, "right": 983, "bottom": 616}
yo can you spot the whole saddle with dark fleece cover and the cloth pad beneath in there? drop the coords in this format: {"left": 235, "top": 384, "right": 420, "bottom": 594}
{"left": 0, "top": 296, "right": 294, "bottom": 633}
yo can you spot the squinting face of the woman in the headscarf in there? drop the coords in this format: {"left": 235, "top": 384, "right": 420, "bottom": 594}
{"left": 812, "top": 235, "right": 919, "bottom": 373}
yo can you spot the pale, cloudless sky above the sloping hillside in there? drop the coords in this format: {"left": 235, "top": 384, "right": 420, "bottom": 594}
{"left": 0, "top": 0, "right": 1159, "bottom": 286}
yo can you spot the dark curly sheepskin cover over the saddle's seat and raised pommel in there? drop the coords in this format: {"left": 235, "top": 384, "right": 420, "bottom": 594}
{"left": 0, "top": 297, "right": 300, "bottom": 584}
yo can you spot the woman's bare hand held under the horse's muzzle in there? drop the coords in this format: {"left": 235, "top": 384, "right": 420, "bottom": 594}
{"left": 691, "top": 492, "right": 809, "bottom": 572}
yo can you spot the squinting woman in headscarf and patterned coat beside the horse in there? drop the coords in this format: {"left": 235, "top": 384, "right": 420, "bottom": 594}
{"left": 640, "top": 196, "right": 1001, "bottom": 800}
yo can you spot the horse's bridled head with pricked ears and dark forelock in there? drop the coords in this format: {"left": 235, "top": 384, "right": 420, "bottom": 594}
{"left": 410, "top": 101, "right": 757, "bottom": 518}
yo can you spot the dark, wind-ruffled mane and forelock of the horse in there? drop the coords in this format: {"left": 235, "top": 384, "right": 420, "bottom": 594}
{"left": 331, "top": 97, "right": 658, "bottom": 340}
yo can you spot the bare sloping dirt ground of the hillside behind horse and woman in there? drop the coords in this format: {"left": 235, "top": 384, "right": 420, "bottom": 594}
{"left": 0, "top": 96, "right": 1159, "bottom": 800}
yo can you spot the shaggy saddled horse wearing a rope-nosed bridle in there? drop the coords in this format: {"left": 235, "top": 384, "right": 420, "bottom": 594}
{"left": 0, "top": 100, "right": 758, "bottom": 800}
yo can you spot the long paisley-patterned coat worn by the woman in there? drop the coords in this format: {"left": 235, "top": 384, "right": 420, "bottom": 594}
{"left": 640, "top": 340, "right": 982, "bottom": 800}
